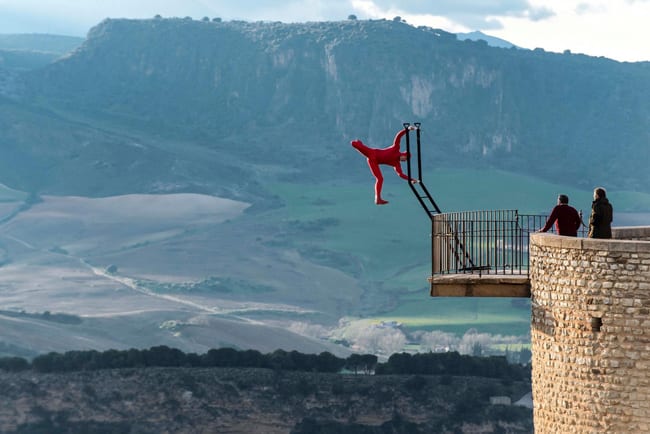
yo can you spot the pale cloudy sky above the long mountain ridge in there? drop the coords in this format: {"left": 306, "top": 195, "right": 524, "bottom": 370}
{"left": 0, "top": 0, "right": 650, "bottom": 62}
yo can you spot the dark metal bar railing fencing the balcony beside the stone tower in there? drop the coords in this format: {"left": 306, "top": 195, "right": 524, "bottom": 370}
{"left": 431, "top": 210, "right": 584, "bottom": 274}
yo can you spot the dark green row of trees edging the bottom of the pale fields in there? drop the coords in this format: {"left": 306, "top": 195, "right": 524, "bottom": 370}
{"left": 0, "top": 345, "right": 530, "bottom": 380}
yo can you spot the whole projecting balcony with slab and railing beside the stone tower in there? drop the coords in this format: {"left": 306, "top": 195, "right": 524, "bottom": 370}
{"left": 429, "top": 210, "right": 586, "bottom": 297}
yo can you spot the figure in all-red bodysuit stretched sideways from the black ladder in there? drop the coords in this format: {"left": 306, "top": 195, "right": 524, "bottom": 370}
{"left": 351, "top": 125, "right": 418, "bottom": 205}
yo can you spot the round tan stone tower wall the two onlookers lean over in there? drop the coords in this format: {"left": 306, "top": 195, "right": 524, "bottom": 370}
{"left": 530, "top": 227, "right": 650, "bottom": 434}
